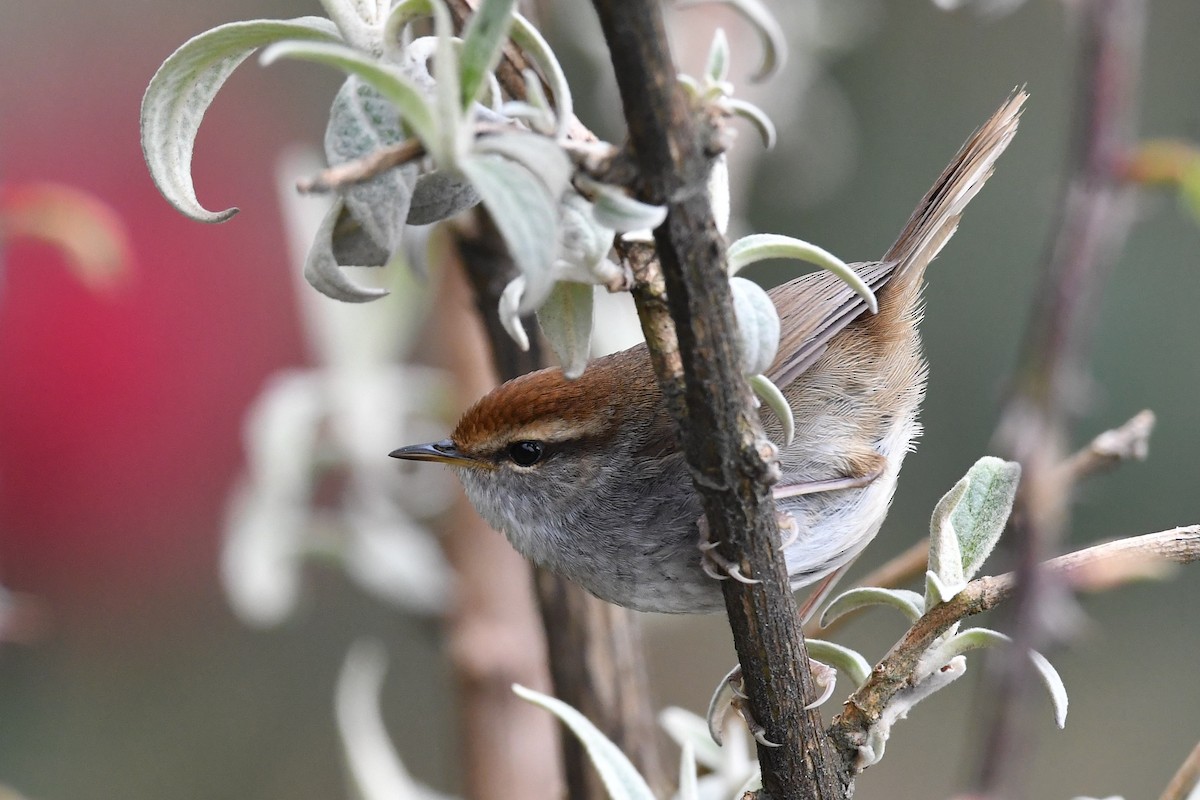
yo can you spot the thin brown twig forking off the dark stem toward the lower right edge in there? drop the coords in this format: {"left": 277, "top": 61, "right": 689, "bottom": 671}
{"left": 829, "top": 525, "right": 1200, "bottom": 759}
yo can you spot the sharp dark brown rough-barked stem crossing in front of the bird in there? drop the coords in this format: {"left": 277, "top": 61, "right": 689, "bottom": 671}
{"left": 594, "top": 0, "right": 850, "bottom": 799}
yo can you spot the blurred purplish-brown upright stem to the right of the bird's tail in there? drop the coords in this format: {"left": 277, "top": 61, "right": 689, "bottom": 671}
{"left": 976, "top": 0, "right": 1146, "bottom": 796}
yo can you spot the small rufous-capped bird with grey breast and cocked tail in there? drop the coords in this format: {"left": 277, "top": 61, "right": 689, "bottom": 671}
{"left": 391, "top": 92, "right": 1026, "bottom": 613}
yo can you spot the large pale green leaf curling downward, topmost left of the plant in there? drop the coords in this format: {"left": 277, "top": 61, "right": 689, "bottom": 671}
{"left": 142, "top": 17, "right": 341, "bottom": 222}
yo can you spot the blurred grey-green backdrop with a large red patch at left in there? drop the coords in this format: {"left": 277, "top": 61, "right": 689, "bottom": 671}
{"left": 0, "top": 0, "right": 1200, "bottom": 800}
